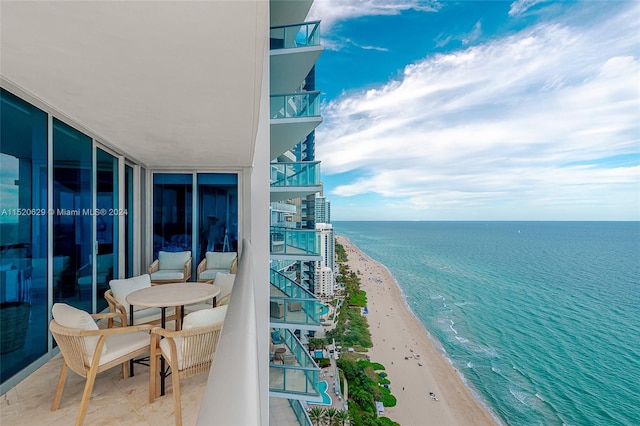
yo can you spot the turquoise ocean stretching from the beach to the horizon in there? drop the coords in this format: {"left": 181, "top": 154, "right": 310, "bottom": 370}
{"left": 333, "top": 222, "right": 640, "bottom": 426}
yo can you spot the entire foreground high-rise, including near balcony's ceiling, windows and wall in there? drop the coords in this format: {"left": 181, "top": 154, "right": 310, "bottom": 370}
{"left": 0, "top": 0, "right": 322, "bottom": 425}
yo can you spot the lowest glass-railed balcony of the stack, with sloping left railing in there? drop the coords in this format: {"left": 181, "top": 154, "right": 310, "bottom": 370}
{"left": 269, "top": 329, "right": 322, "bottom": 402}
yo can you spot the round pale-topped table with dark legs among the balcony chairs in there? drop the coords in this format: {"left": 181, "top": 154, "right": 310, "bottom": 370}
{"left": 125, "top": 283, "right": 220, "bottom": 395}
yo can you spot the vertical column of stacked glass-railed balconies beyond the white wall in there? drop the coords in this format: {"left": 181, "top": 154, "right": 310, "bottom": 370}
{"left": 269, "top": 0, "right": 322, "bottom": 418}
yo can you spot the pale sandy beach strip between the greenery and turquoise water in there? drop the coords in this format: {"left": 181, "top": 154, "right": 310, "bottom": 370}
{"left": 336, "top": 236, "right": 497, "bottom": 426}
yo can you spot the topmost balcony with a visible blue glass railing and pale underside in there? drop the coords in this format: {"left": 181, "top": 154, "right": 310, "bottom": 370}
{"left": 270, "top": 21, "right": 322, "bottom": 93}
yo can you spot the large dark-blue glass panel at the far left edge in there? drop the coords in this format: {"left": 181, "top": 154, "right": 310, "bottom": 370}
{"left": 0, "top": 89, "right": 48, "bottom": 383}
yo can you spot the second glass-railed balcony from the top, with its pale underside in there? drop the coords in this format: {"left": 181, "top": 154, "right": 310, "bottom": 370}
{"left": 270, "top": 91, "right": 322, "bottom": 160}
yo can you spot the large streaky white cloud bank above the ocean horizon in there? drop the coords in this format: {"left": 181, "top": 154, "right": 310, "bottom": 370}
{"left": 316, "top": 5, "right": 640, "bottom": 219}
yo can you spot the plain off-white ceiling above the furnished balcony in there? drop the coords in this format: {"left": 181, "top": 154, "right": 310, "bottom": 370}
{"left": 0, "top": 1, "right": 268, "bottom": 168}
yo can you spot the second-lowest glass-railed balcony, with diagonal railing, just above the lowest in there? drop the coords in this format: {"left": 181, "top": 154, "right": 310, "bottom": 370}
{"left": 269, "top": 269, "right": 322, "bottom": 330}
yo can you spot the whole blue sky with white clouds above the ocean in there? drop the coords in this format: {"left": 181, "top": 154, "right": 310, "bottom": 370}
{"left": 307, "top": 0, "right": 640, "bottom": 221}
